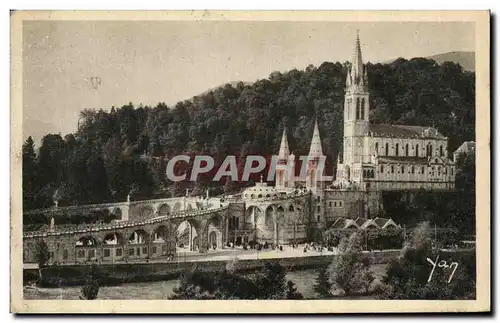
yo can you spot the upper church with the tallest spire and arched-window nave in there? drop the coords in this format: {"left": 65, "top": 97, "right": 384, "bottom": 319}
{"left": 334, "top": 36, "right": 455, "bottom": 190}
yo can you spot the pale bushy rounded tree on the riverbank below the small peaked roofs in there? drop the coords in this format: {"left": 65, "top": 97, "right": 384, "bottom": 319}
{"left": 327, "top": 233, "right": 369, "bottom": 295}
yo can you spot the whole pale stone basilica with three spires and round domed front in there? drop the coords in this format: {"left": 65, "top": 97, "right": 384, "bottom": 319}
{"left": 236, "top": 35, "right": 455, "bottom": 243}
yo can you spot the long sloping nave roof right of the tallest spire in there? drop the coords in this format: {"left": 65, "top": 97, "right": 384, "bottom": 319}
{"left": 369, "top": 124, "right": 446, "bottom": 139}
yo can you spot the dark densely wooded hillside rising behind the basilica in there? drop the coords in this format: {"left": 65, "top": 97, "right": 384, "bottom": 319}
{"left": 22, "top": 58, "right": 475, "bottom": 209}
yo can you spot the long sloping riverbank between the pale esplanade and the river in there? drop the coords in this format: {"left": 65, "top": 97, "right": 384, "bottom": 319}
{"left": 24, "top": 250, "right": 399, "bottom": 287}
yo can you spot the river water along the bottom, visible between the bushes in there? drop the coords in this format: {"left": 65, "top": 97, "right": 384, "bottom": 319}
{"left": 24, "top": 265, "right": 386, "bottom": 300}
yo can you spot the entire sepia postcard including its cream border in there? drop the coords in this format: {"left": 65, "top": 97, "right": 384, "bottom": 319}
{"left": 11, "top": 11, "right": 491, "bottom": 313}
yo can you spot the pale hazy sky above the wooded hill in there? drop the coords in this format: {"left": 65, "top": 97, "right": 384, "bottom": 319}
{"left": 23, "top": 21, "right": 475, "bottom": 145}
